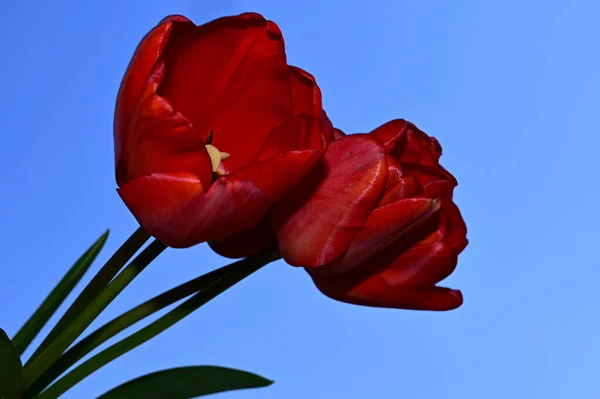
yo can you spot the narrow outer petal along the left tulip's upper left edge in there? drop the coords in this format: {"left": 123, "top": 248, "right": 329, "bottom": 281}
{"left": 114, "top": 15, "right": 196, "bottom": 169}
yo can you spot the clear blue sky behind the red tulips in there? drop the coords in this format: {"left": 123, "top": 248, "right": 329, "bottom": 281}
{"left": 0, "top": 0, "right": 600, "bottom": 399}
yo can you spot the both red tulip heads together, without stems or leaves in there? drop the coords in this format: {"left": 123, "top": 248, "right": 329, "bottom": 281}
{"left": 115, "top": 13, "right": 467, "bottom": 310}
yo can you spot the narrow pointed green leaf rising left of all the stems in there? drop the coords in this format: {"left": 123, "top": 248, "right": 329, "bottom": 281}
{"left": 13, "top": 230, "right": 109, "bottom": 354}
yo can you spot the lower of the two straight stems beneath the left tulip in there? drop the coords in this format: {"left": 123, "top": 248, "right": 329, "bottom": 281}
{"left": 23, "top": 240, "right": 166, "bottom": 389}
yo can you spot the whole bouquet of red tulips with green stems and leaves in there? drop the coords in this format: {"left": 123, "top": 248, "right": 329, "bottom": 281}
{"left": 0, "top": 13, "right": 467, "bottom": 399}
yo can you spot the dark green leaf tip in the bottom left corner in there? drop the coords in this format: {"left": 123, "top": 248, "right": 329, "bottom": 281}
{"left": 0, "top": 328, "right": 23, "bottom": 399}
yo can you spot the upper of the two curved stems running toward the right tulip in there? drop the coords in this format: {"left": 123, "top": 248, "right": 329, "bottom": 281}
{"left": 26, "top": 266, "right": 232, "bottom": 396}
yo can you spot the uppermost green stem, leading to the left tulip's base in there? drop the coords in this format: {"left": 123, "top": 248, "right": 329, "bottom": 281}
{"left": 25, "top": 227, "right": 150, "bottom": 367}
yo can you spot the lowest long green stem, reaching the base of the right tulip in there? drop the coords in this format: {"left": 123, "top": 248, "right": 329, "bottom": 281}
{"left": 38, "top": 251, "right": 281, "bottom": 399}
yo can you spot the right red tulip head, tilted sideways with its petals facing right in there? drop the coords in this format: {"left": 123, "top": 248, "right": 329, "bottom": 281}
{"left": 271, "top": 120, "right": 467, "bottom": 310}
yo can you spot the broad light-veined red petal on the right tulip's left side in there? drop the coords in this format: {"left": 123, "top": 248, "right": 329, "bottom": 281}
{"left": 271, "top": 135, "right": 387, "bottom": 267}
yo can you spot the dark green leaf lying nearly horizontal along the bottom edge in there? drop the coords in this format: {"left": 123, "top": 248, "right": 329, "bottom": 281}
{"left": 98, "top": 366, "right": 273, "bottom": 399}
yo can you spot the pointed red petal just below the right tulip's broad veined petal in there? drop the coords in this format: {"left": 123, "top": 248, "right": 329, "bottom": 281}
{"left": 322, "top": 198, "right": 441, "bottom": 273}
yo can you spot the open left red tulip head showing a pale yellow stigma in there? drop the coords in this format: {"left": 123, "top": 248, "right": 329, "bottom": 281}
{"left": 114, "top": 13, "right": 333, "bottom": 247}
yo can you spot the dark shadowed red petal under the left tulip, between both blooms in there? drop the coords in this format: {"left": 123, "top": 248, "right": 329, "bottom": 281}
{"left": 208, "top": 222, "right": 277, "bottom": 259}
